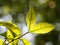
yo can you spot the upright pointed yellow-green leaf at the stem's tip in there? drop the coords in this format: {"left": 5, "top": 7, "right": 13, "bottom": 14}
{"left": 26, "top": 6, "right": 36, "bottom": 29}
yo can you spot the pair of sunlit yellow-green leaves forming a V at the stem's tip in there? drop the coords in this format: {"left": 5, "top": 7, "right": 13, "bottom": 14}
{"left": 26, "top": 7, "right": 55, "bottom": 34}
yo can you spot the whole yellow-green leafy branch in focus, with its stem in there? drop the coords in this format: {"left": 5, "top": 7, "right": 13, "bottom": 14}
{"left": 0, "top": 6, "right": 55, "bottom": 45}
